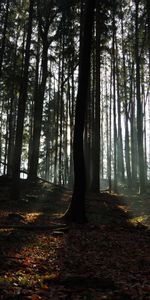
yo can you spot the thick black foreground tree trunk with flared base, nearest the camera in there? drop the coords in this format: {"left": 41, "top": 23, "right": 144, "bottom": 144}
{"left": 64, "top": 0, "right": 95, "bottom": 223}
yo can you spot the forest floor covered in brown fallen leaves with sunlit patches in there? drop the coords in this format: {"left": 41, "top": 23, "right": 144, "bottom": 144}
{"left": 0, "top": 181, "right": 150, "bottom": 300}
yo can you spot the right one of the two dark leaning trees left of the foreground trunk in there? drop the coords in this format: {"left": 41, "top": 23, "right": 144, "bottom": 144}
{"left": 29, "top": 1, "right": 55, "bottom": 180}
